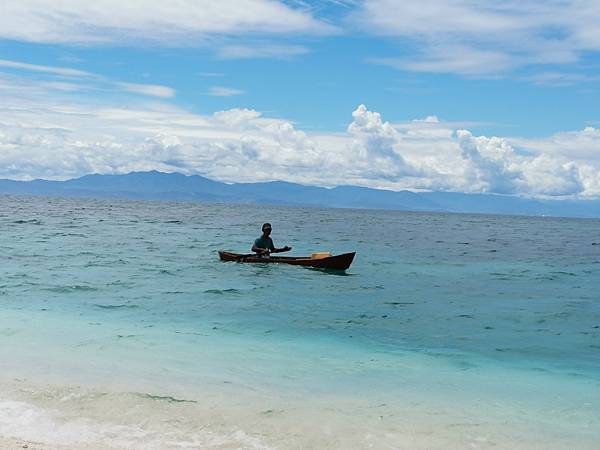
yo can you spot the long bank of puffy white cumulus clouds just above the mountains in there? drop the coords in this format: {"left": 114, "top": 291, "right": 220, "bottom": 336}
{"left": 0, "top": 75, "right": 600, "bottom": 197}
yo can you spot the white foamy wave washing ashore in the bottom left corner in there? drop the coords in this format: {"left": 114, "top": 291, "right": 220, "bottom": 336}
{"left": 0, "top": 398, "right": 270, "bottom": 450}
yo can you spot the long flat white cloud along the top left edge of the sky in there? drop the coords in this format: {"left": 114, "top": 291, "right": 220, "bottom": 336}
{"left": 0, "top": 0, "right": 334, "bottom": 45}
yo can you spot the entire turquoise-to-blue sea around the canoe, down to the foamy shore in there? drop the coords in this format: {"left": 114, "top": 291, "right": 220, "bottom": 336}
{"left": 0, "top": 196, "right": 600, "bottom": 450}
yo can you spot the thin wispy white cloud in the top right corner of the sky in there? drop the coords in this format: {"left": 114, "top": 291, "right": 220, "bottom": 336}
{"left": 352, "top": 0, "right": 600, "bottom": 76}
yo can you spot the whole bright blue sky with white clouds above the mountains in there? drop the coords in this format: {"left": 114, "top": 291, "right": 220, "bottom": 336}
{"left": 0, "top": 0, "right": 600, "bottom": 199}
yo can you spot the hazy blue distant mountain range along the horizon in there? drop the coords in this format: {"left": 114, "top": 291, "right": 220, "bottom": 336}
{"left": 0, "top": 171, "right": 600, "bottom": 218}
